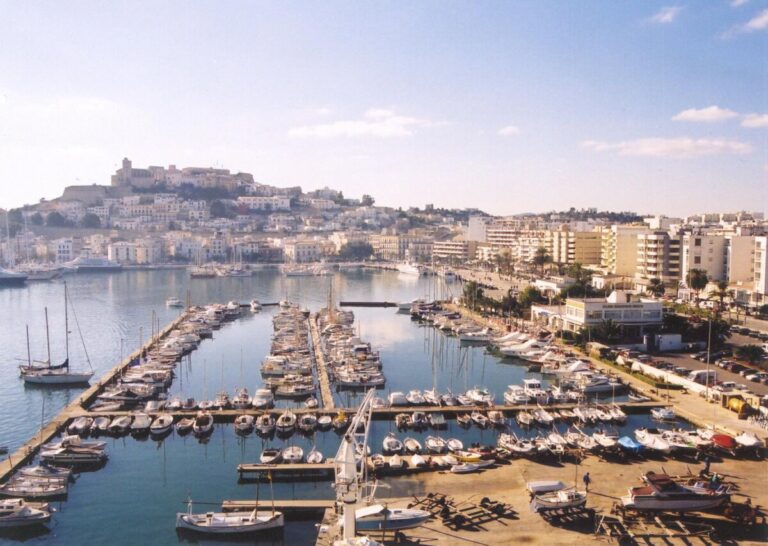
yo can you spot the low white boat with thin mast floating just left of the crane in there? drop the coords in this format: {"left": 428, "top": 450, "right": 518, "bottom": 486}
{"left": 176, "top": 503, "right": 285, "bottom": 535}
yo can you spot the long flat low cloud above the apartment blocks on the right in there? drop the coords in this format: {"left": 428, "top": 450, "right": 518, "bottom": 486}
{"left": 582, "top": 137, "right": 752, "bottom": 159}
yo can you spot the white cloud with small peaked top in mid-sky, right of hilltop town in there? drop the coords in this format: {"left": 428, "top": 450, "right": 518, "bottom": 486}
{"left": 288, "top": 108, "right": 441, "bottom": 138}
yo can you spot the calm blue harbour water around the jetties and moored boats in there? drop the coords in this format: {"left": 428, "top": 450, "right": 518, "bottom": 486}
{"left": 0, "top": 271, "right": 684, "bottom": 545}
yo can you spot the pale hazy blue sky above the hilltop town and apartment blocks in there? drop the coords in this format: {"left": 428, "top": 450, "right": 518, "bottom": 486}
{"left": 0, "top": 0, "right": 768, "bottom": 214}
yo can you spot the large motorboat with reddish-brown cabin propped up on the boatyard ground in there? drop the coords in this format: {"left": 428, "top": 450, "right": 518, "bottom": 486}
{"left": 621, "top": 472, "right": 730, "bottom": 513}
